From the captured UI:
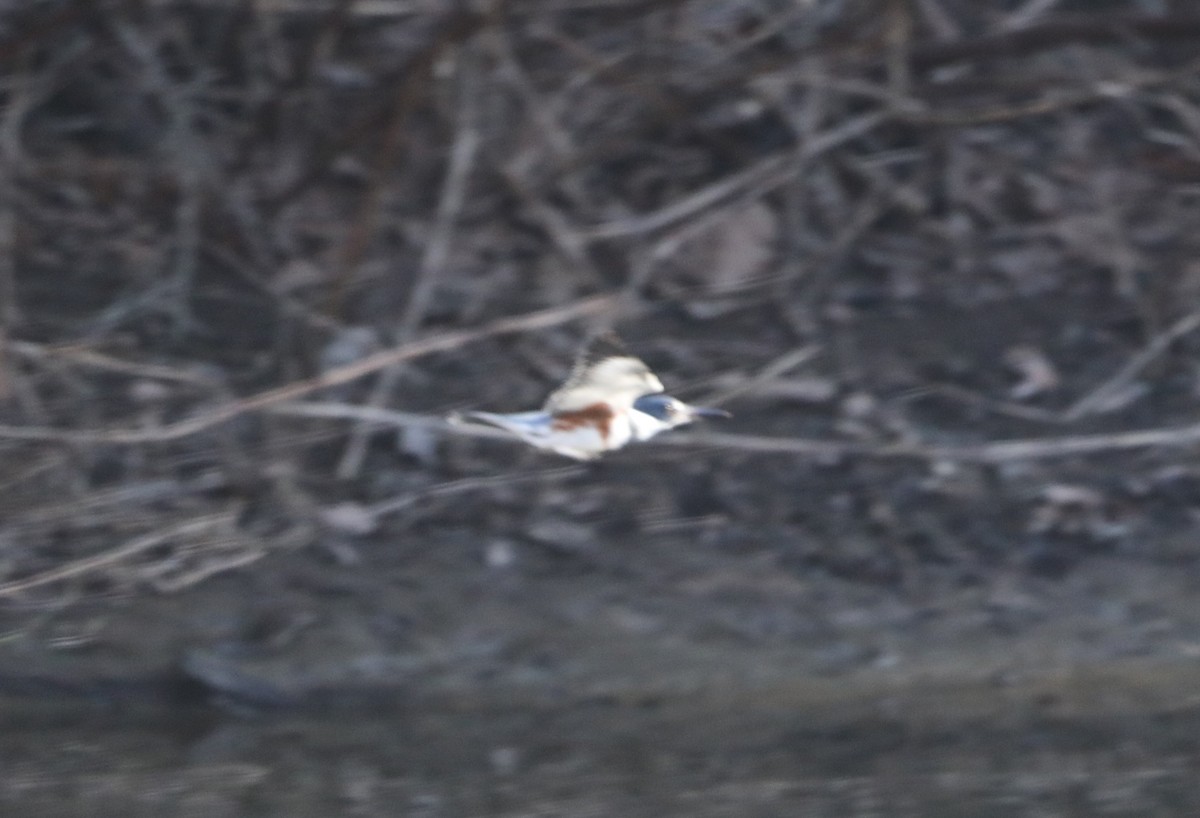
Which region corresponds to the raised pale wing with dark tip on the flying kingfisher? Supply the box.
[545,332,662,414]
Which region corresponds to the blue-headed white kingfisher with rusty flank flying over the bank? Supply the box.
[450,333,730,461]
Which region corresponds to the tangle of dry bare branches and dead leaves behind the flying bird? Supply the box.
[0,0,1200,686]
